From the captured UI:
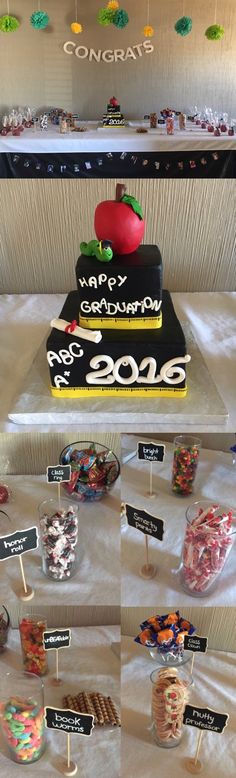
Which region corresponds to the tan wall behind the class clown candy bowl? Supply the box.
[121,603,236,652]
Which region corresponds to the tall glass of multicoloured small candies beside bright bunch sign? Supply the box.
[172,435,201,495]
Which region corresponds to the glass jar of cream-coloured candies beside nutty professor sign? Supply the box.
[150,668,190,748]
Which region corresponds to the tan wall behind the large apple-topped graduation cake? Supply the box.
[0,177,236,293]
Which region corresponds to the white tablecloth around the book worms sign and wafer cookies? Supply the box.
[0,625,120,778]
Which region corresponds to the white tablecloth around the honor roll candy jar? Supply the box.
[0,472,120,612]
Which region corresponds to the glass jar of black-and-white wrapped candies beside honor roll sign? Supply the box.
[38,499,79,581]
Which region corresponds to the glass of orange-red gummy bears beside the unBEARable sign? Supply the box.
[19,613,48,675]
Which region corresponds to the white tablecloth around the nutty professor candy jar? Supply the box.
[122,637,236,778]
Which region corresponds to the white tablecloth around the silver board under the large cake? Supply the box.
[0,292,236,432]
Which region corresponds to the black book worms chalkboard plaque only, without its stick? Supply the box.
[45,707,94,737]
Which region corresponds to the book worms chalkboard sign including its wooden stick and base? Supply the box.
[44,707,94,776]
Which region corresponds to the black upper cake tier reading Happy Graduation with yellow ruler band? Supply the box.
[76,246,162,329]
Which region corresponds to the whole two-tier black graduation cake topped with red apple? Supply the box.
[47,184,190,398]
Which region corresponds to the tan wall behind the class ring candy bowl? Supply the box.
[0,427,120,475]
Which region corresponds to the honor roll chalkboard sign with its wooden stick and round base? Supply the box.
[0,514,39,602]
